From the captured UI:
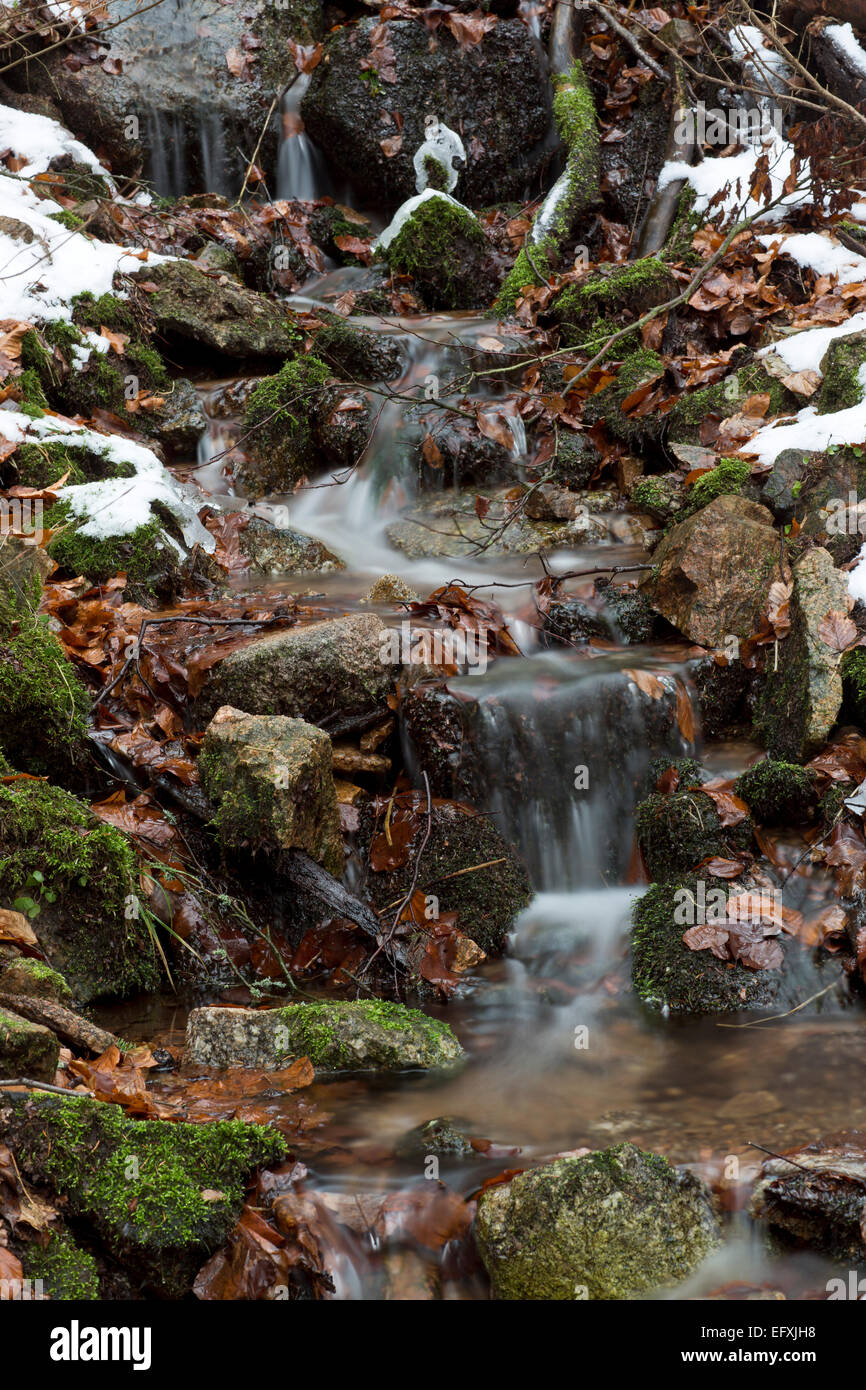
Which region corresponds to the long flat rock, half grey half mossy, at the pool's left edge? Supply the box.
[185,999,463,1072]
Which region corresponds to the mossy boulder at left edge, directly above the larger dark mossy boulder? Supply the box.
[0,585,89,774]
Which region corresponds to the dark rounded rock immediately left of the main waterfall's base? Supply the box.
[360,802,530,955]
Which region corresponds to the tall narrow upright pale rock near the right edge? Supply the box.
[755,546,848,762]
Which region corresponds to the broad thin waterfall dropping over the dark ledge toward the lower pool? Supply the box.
[428,652,691,892]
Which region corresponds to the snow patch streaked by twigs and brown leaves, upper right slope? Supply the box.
[659,129,812,222]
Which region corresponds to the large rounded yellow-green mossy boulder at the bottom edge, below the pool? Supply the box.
[475,1144,721,1301]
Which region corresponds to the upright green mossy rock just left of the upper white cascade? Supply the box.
[239,357,332,496]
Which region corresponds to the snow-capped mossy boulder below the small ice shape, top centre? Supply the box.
[377,190,493,309]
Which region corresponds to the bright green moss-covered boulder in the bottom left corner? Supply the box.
[0,1094,286,1298]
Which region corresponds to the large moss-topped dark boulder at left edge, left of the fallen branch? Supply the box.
[0,778,158,1001]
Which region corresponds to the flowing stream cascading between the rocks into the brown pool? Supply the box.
[96,125,866,1298]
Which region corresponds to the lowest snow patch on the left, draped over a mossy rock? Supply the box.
[0,410,215,553]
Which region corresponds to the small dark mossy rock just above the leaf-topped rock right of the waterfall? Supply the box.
[635,791,752,881]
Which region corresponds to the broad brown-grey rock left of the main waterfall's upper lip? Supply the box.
[196,613,396,727]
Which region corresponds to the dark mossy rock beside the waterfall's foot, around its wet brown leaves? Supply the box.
[631,876,780,1015]
